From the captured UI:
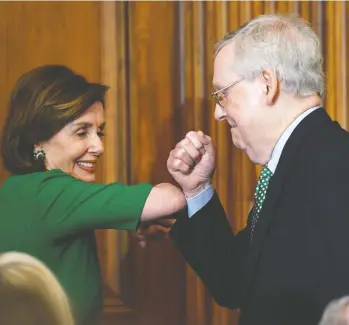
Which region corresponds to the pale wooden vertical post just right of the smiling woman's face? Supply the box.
[97,2,135,324]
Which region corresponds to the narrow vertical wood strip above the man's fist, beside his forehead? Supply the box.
[178,1,208,325]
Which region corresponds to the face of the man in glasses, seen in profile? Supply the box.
[213,44,269,163]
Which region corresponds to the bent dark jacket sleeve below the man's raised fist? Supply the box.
[171,193,249,308]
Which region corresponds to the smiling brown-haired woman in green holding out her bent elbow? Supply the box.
[0,65,186,325]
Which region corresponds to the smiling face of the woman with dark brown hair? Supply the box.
[36,102,105,182]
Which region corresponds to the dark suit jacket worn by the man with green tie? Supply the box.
[171,108,349,325]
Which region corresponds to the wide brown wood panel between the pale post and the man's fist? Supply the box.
[128,2,185,325]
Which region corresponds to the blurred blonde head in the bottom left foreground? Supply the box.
[0,252,74,325]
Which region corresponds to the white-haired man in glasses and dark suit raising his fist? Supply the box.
[167,15,349,325]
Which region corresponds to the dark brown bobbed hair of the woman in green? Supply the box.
[1,65,108,174]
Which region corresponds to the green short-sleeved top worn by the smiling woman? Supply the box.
[0,169,152,325]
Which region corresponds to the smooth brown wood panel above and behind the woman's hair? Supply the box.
[0,2,100,182]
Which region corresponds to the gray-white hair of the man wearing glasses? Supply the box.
[215,15,324,96]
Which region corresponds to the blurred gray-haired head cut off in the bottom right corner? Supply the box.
[319,296,349,325]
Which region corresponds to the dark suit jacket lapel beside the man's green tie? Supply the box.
[239,108,331,300]
